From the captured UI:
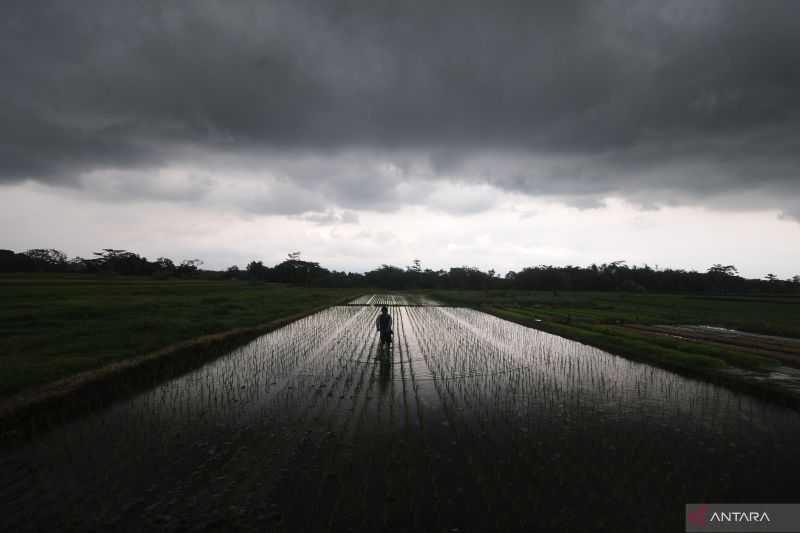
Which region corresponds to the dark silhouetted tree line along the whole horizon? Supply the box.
[0,248,800,293]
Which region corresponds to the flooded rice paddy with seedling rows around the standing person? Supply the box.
[0,296,800,532]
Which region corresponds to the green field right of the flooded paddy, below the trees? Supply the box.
[432,291,800,369]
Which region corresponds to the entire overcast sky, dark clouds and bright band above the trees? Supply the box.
[0,0,800,277]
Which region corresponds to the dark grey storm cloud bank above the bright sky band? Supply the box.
[0,0,800,216]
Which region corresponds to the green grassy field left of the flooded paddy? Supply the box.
[0,274,361,395]
